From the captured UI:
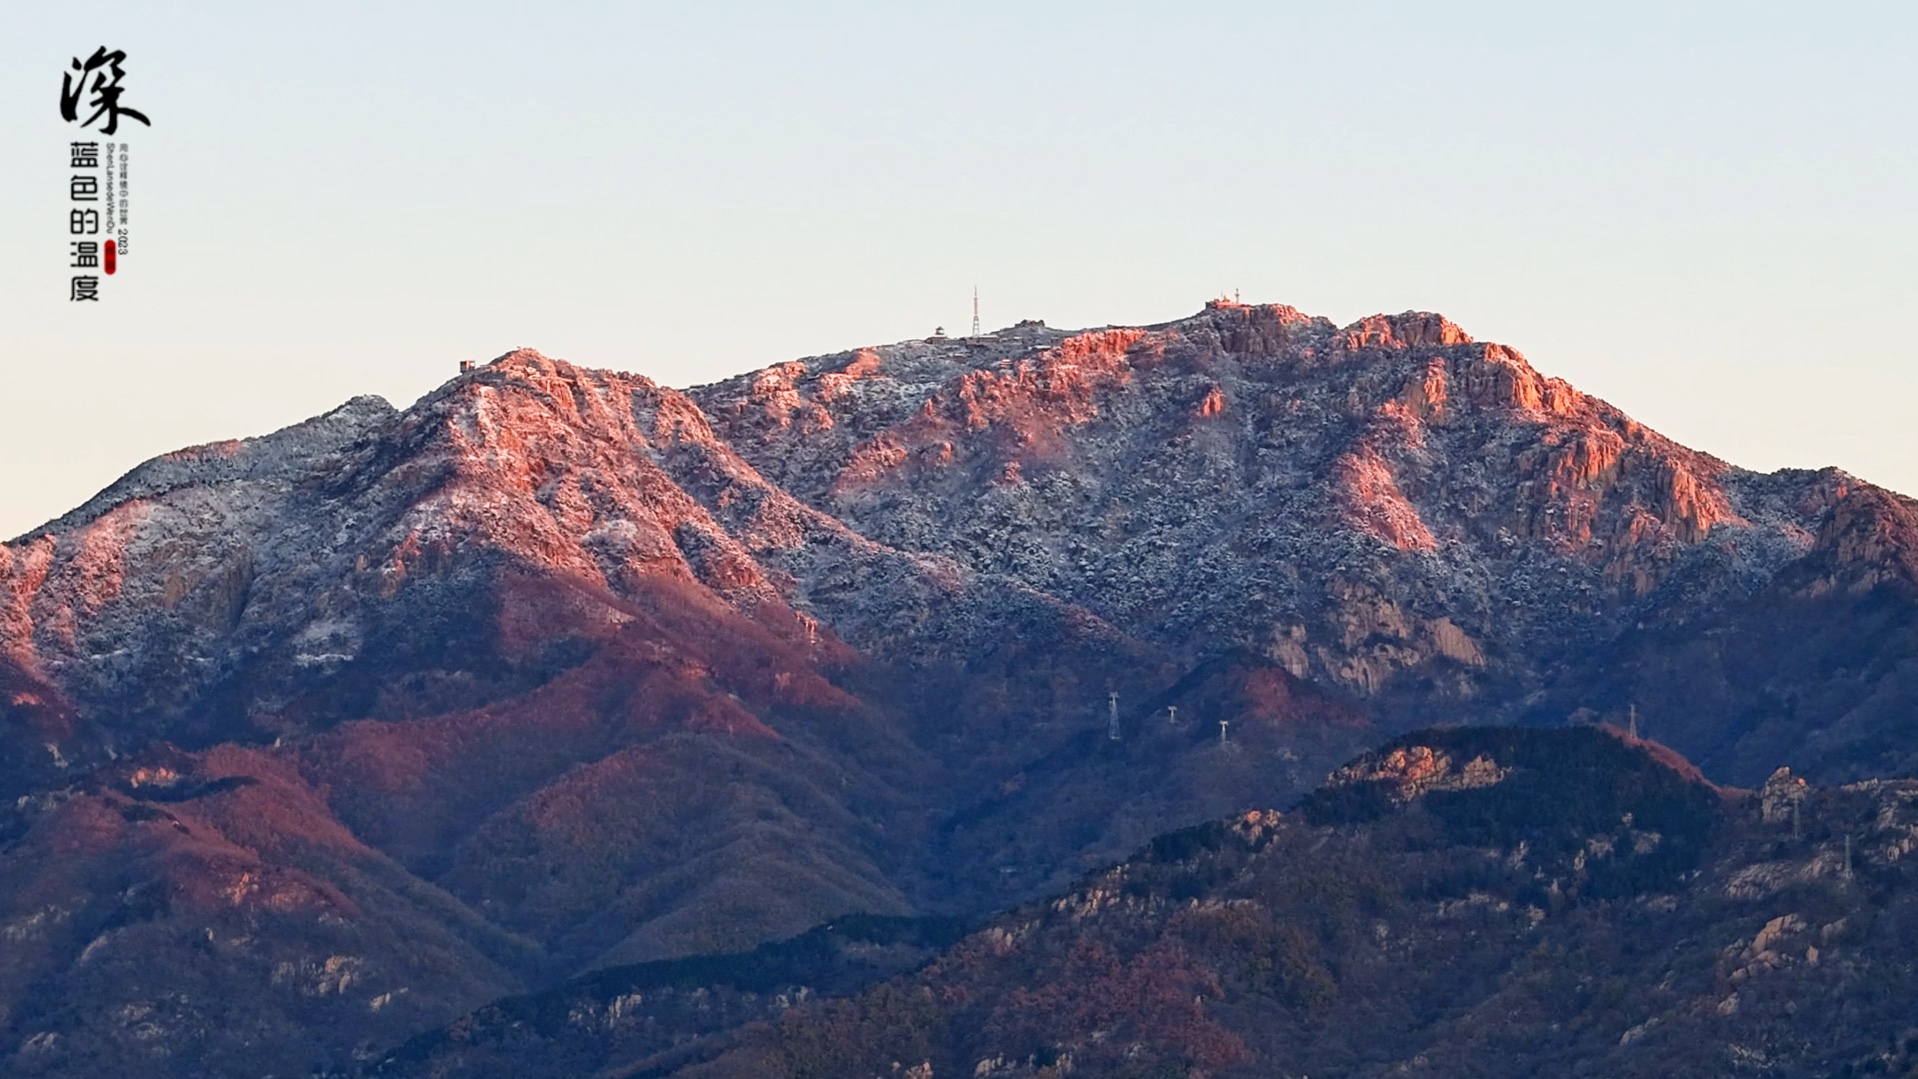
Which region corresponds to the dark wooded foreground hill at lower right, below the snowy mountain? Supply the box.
[389,726,1918,1079]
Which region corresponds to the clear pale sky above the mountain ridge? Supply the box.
[0,2,1918,537]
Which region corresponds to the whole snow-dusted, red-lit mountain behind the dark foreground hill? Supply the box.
[0,301,1918,1075]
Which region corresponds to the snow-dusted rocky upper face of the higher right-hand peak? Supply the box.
[694,305,1779,709]
